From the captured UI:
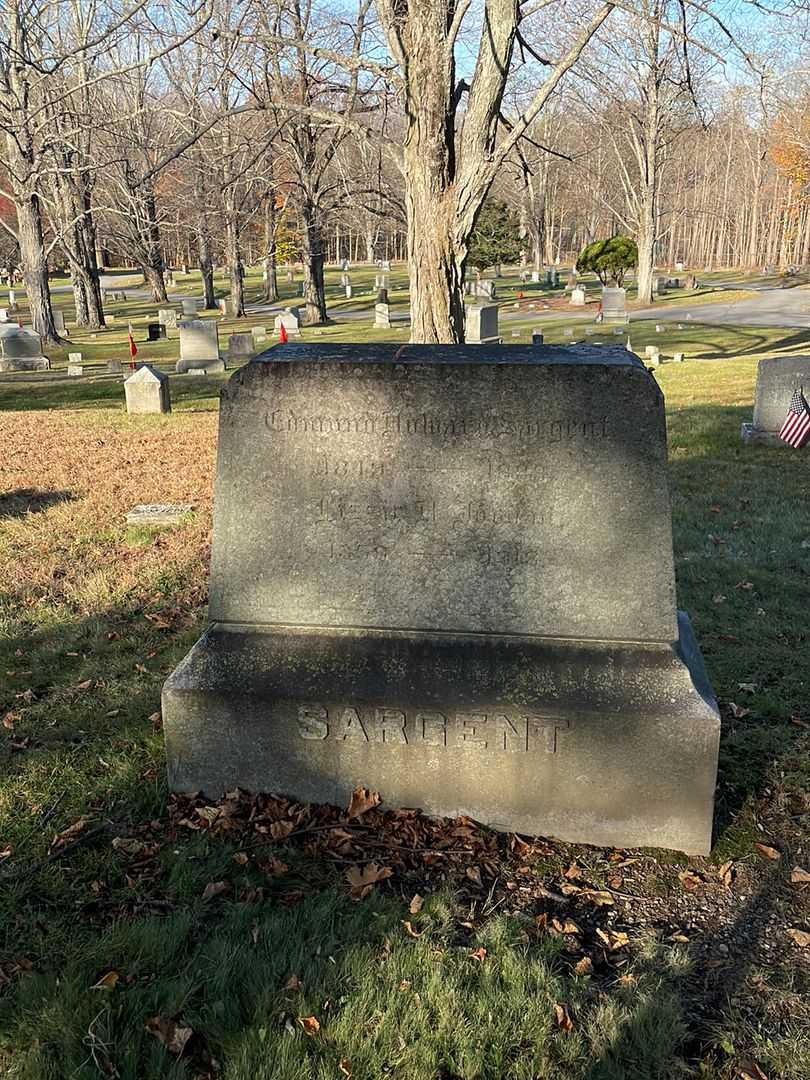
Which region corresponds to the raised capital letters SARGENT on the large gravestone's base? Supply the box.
[298,705,570,754]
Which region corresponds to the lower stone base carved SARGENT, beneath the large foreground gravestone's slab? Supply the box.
[163,613,719,854]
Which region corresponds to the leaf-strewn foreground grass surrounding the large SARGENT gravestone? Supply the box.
[0,359,810,1080]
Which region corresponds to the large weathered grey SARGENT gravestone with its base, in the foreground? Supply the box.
[162,343,720,854]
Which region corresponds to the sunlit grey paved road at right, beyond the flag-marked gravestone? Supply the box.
[631,285,810,327]
